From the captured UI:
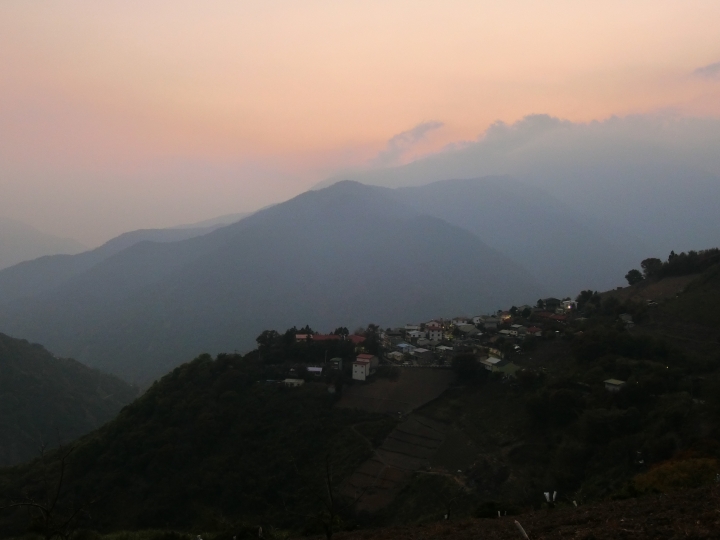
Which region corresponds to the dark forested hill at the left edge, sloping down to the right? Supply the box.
[0,334,137,466]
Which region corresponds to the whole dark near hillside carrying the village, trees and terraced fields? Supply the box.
[0,252,720,539]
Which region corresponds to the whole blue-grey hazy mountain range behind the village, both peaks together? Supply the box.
[0,169,712,383]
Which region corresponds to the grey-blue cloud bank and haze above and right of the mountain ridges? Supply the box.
[325,113,720,256]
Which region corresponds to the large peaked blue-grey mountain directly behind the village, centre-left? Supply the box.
[0,182,544,382]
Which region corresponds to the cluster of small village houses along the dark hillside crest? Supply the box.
[273,291,636,392]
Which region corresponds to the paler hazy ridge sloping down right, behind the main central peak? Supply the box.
[397,176,637,297]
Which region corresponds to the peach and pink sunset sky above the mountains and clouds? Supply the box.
[0,0,720,245]
